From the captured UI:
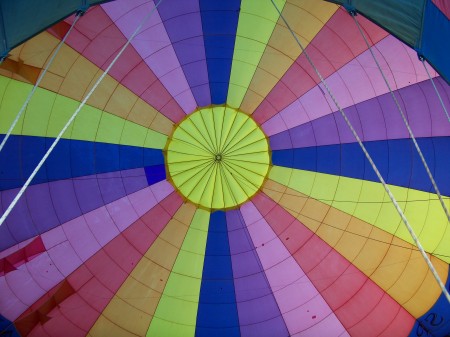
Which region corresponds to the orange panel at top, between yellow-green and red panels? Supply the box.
[241,0,339,114]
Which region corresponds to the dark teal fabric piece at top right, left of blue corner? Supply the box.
[327,0,426,48]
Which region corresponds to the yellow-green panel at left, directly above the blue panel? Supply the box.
[0,76,167,149]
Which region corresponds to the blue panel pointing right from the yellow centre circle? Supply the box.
[272,137,450,196]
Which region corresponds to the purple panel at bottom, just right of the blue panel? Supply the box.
[226,210,289,337]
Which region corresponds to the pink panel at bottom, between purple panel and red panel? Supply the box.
[241,202,345,336]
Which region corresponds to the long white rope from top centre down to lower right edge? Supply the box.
[270,0,450,303]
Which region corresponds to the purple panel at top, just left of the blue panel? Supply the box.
[158,0,211,106]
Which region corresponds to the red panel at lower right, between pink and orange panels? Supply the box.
[252,194,415,336]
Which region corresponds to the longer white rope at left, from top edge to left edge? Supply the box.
[0,0,163,226]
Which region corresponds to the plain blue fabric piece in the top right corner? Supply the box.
[419,0,450,83]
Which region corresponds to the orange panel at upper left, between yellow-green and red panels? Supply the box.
[0,32,173,134]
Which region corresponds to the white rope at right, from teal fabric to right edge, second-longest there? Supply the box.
[350,13,450,221]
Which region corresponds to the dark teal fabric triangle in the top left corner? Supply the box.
[0,0,106,55]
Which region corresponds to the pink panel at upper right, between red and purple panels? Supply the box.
[262,36,436,136]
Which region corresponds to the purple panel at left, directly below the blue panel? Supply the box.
[0,168,148,250]
